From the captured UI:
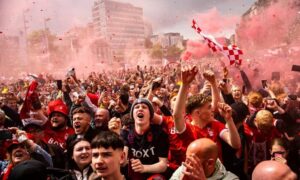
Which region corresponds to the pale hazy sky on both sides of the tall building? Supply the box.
[0,0,255,38]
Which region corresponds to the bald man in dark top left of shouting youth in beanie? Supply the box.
[94,108,110,130]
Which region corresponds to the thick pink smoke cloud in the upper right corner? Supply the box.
[237,0,299,49]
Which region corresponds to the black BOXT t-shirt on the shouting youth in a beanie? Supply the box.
[121,125,169,179]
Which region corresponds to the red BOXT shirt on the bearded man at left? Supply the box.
[44,124,75,149]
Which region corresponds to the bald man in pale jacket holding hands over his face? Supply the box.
[171,138,239,180]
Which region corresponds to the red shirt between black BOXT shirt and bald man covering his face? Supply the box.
[161,116,194,170]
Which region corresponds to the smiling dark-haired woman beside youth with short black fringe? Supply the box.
[62,138,93,180]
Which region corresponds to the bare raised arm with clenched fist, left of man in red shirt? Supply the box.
[173,66,198,132]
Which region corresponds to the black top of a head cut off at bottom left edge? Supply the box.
[8,160,47,180]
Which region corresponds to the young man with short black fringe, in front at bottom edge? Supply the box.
[91,131,125,180]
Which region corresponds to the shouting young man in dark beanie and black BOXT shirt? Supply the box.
[121,98,169,180]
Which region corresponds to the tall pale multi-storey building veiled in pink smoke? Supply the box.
[92,0,145,63]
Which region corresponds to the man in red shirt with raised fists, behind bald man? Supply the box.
[174,66,241,159]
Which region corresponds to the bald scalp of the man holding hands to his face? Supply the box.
[186,138,218,160]
